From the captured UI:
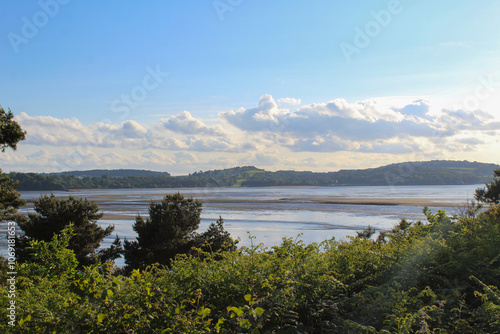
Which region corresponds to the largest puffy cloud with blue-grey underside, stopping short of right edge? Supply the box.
[220,95,437,140]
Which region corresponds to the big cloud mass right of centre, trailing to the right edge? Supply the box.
[220,95,500,154]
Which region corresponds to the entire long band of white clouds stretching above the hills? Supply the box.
[8,95,500,170]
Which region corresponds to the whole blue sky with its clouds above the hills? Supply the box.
[0,0,500,175]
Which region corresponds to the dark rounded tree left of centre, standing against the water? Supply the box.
[124,193,235,270]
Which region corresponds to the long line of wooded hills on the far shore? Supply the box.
[10,160,500,190]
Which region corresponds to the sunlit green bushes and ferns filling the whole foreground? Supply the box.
[0,198,500,333]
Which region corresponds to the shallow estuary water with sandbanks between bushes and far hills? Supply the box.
[14,185,482,253]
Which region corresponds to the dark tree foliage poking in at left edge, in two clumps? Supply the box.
[0,106,26,221]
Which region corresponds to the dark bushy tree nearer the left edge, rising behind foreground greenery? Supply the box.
[18,194,121,266]
